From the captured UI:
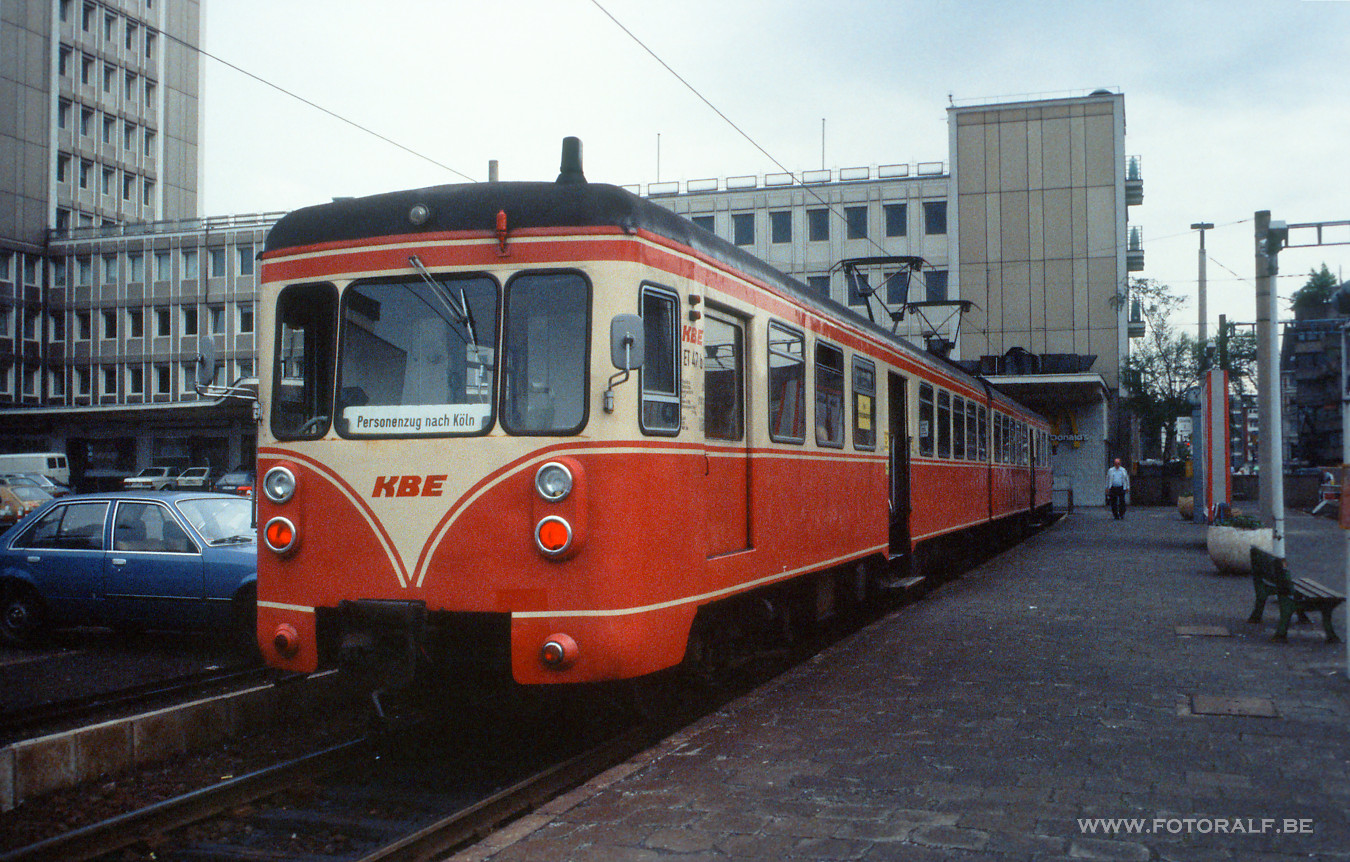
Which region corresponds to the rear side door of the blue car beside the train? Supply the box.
[9,500,109,623]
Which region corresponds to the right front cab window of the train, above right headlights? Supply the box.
[502,272,590,434]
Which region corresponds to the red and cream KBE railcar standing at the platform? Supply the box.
[258,145,1049,684]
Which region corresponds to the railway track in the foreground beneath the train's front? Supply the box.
[0,726,659,862]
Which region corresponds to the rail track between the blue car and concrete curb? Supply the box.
[0,662,275,742]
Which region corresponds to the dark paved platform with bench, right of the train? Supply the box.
[456,509,1350,862]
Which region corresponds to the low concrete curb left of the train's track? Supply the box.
[0,672,338,811]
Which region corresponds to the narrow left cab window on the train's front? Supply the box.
[271,285,338,440]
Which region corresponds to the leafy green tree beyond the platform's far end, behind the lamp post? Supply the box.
[1116,278,1199,461]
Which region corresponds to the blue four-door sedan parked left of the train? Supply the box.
[0,491,258,646]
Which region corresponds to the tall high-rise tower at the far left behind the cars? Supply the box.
[0,0,201,415]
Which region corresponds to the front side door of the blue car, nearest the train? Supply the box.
[105,500,205,629]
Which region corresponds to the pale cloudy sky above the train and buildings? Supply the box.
[201,0,1350,335]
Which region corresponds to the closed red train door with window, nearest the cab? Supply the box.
[703,310,751,557]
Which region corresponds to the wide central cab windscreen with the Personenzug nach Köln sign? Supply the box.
[338,274,498,437]
